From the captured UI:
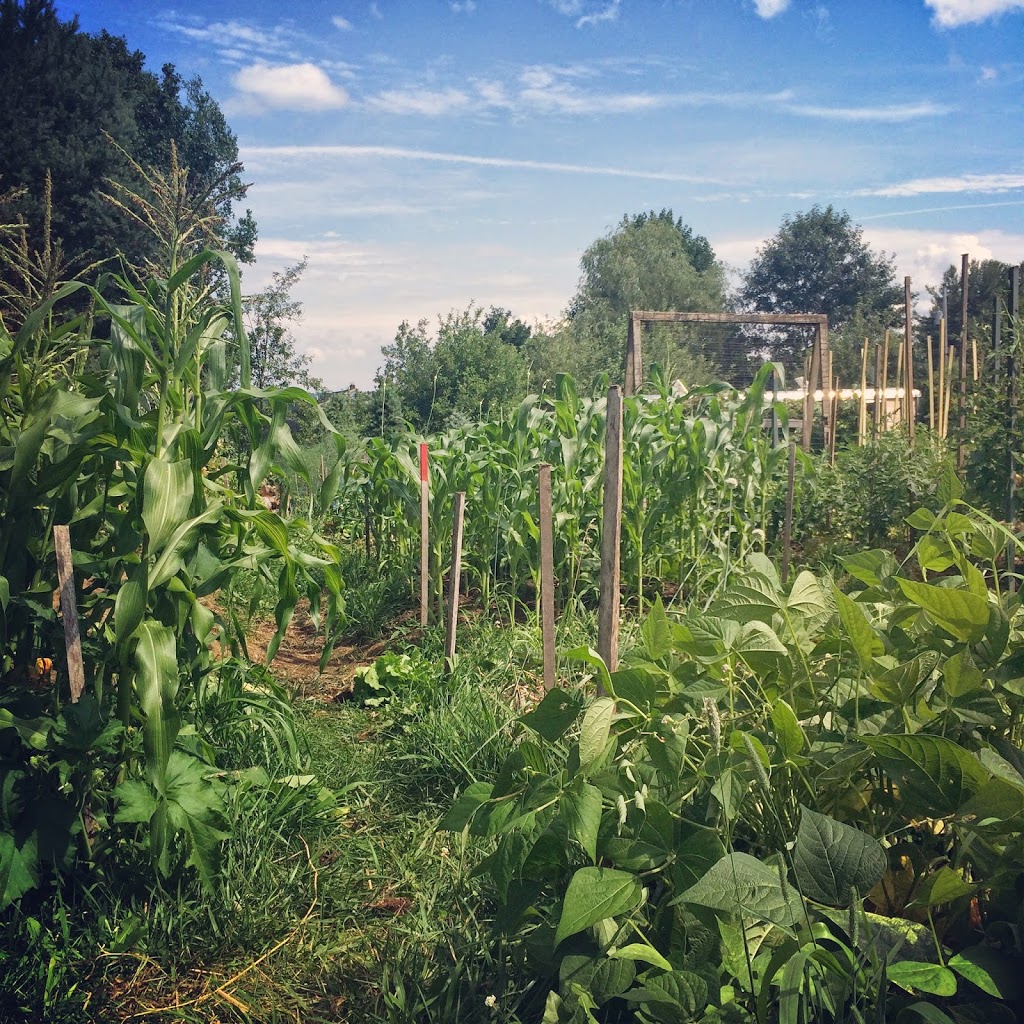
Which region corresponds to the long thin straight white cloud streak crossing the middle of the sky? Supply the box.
[242,145,728,185]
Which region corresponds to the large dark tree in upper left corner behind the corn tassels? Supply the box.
[0,0,255,288]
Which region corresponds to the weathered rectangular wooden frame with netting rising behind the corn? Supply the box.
[623,309,833,452]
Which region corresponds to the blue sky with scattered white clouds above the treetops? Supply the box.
[56,0,1024,387]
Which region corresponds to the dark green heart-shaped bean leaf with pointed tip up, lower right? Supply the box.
[793,806,886,906]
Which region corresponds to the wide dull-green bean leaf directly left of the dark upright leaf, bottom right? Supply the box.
[673,853,804,933]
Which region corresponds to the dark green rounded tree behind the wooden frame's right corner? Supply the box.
[740,206,903,373]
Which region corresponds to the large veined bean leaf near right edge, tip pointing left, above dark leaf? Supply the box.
[860,733,989,817]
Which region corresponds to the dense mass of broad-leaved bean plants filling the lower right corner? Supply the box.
[440,503,1024,1024]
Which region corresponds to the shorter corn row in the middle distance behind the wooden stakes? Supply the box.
[337,367,785,610]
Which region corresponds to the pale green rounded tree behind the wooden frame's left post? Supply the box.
[552,210,725,382]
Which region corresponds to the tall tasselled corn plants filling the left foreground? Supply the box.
[0,149,343,923]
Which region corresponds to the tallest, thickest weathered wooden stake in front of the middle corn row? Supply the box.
[597,386,623,679]
